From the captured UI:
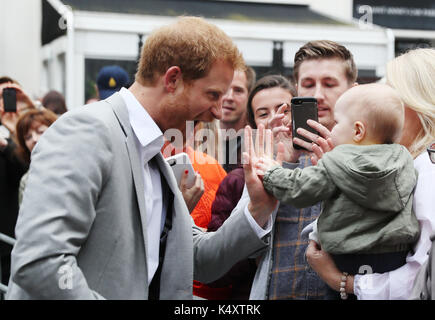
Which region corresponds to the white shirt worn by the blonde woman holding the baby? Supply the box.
[354,151,435,300]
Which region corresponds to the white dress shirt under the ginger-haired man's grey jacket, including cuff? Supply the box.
[119,88,272,284]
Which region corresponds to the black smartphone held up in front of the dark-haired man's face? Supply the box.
[291,97,319,150]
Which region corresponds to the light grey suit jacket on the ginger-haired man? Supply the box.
[7,94,269,299]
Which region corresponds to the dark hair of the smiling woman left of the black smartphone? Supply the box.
[247,74,296,129]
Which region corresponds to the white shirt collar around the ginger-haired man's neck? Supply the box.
[119,88,164,161]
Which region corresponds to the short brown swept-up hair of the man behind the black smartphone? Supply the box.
[293,40,358,84]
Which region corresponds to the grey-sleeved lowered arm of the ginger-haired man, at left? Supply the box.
[11,112,113,299]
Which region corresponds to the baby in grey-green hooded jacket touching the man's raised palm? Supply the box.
[256,84,419,296]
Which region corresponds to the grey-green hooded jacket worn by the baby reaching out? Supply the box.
[263,144,420,254]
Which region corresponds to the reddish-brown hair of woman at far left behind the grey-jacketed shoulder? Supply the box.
[15,108,57,163]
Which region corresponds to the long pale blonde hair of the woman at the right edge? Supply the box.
[387,48,435,158]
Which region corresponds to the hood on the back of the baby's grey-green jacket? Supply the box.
[321,144,417,211]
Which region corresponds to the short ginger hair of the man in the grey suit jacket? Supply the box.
[136,17,244,85]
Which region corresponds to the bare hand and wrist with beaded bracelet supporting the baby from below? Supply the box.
[305,240,354,294]
